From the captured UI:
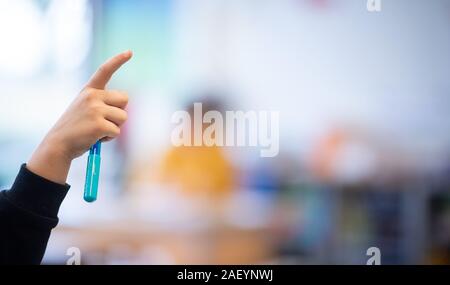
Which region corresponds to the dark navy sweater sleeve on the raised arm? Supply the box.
[0,164,70,264]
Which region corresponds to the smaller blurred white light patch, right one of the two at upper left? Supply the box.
[48,0,93,70]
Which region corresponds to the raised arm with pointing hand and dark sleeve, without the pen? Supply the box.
[0,51,132,263]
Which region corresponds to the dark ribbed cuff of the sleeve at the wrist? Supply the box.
[6,164,70,218]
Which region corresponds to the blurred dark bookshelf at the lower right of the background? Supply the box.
[278,175,450,264]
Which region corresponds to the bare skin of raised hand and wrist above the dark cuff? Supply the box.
[26,51,132,184]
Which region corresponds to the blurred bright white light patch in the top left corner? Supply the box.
[0,0,45,76]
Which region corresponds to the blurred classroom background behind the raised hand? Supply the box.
[0,0,450,264]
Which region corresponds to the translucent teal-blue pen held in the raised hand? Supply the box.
[83,141,102,203]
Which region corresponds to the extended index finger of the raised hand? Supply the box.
[86,51,133,89]
